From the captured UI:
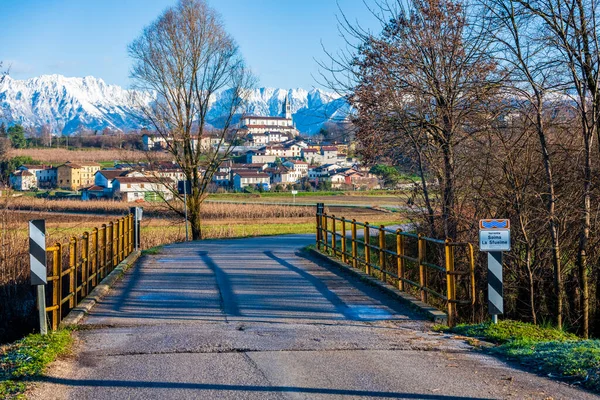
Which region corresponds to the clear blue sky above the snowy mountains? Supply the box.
[0,0,375,89]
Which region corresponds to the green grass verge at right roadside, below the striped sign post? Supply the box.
[434,320,600,393]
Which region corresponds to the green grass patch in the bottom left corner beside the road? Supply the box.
[0,329,73,399]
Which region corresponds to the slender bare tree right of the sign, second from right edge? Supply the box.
[482,0,564,328]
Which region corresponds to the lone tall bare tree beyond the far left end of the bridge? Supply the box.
[129,0,253,240]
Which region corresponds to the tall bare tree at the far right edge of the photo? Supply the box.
[519,0,600,337]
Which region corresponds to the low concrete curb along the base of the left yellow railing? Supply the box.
[60,251,142,327]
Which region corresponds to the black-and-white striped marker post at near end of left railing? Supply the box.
[29,219,48,335]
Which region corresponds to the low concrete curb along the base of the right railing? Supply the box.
[305,248,448,325]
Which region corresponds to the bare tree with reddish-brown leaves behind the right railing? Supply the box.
[333,0,497,238]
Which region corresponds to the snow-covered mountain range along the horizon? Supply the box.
[0,75,349,134]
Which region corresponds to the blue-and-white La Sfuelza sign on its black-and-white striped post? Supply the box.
[479,219,510,324]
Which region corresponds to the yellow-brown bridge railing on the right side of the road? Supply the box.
[316,207,475,326]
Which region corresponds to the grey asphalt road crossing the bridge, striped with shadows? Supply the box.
[29,235,597,400]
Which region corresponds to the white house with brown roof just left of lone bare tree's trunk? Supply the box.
[113,177,173,202]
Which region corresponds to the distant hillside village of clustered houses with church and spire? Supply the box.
[10,95,379,202]
